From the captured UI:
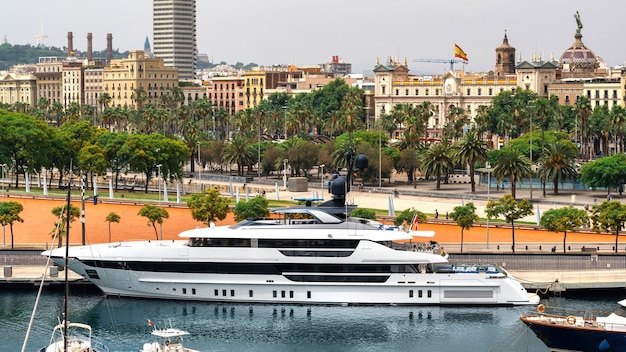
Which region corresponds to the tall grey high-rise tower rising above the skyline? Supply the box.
[152,0,197,80]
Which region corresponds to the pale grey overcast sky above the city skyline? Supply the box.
[0,0,626,73]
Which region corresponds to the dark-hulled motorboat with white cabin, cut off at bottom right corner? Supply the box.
[520,299,626,352]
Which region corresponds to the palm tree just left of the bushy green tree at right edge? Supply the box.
[540,140,578,194]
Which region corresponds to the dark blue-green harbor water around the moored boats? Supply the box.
[0,286,624,352]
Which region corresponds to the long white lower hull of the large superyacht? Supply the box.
[53,252,539,306]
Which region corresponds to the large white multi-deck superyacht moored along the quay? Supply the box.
[44,202,539,305]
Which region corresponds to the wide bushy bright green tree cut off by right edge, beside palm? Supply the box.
[580,154,626,194]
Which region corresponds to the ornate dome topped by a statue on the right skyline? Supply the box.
[559,11,600,76]
